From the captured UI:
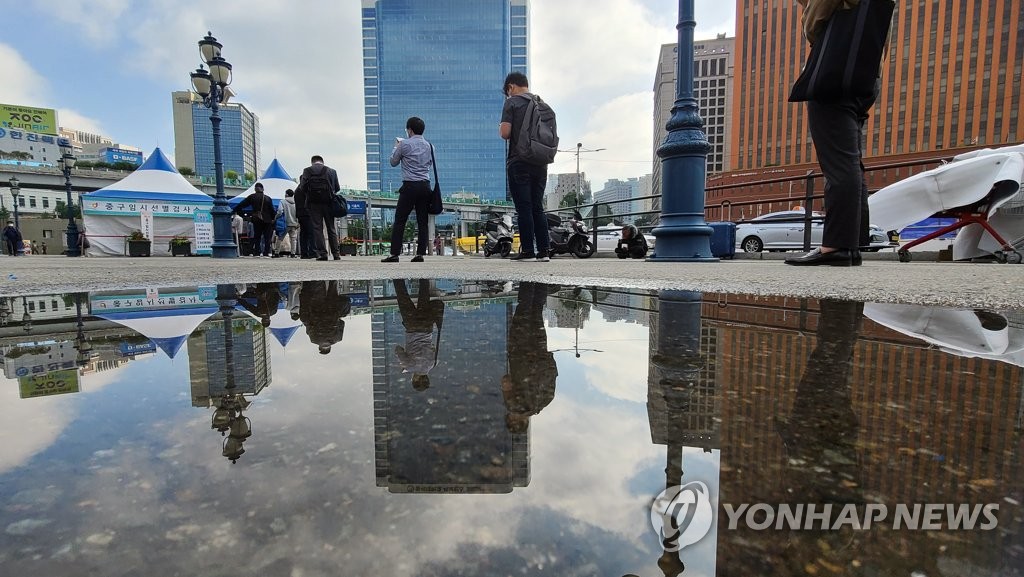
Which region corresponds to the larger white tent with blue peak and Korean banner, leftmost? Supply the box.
[82,148,213,256]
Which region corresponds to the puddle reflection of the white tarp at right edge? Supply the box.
[864,302,1024,367]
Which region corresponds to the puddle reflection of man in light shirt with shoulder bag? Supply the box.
[394,279,444,390]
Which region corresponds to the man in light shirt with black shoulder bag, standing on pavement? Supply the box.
[381,116,434,262]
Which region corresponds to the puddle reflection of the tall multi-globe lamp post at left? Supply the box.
[210,285,252,464]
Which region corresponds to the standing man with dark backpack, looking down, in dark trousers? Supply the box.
[498,72,558,262]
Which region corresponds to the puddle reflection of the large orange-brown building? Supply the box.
[700,295,1024,575]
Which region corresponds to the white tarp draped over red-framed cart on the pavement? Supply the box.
[867,145,1024,260]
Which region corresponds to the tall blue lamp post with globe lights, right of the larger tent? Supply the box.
[189,32,239,258]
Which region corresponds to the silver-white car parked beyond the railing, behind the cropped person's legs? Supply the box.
[736,210,895,252]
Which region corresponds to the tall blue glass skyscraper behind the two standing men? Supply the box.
[362,0,529,201]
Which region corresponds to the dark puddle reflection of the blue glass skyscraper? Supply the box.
[371,282,529,494]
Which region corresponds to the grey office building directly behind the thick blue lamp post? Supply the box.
[651,34,736,201]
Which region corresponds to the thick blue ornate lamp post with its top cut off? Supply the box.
[648,0,718,262]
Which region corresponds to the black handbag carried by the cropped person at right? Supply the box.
[790,0,896,102]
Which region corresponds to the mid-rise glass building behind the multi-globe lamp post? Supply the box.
[171,91,263,178]
